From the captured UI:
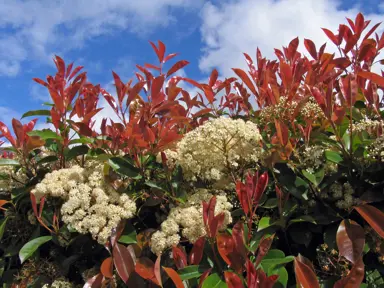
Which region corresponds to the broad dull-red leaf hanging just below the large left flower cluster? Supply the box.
[113,243,135,283]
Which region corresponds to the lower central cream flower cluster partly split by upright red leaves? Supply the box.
[151,189,232,255]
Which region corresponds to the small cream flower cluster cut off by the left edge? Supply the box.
[0,166,28,191]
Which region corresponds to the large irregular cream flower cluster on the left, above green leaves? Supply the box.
[32,161,136,244]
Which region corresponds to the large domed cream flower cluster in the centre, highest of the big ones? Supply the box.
[176,117,261,181]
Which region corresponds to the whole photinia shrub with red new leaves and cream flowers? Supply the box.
[0,13,384,288]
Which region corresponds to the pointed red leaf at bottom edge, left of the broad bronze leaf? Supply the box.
[294,254,320,288]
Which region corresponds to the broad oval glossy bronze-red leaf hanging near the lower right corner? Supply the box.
[336,220,365,264]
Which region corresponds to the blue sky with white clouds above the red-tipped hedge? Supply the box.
[0,0,384,129]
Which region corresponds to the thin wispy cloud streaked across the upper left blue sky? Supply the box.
[0,0,203,76]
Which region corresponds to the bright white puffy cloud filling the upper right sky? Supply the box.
[199,0,384,76]
